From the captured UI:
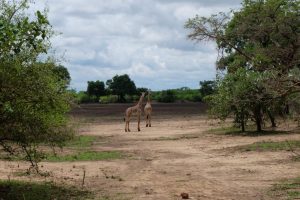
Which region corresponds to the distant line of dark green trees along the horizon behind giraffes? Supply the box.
[72,74,215,103]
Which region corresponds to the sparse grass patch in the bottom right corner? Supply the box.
[269,177,300,200]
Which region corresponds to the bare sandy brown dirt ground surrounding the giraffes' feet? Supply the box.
[0,103,300,200]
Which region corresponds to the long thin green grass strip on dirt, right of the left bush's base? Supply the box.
[44,151,124,162]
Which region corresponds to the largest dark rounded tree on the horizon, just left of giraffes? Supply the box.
[106,74,136,102]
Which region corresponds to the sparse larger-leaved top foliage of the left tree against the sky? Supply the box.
[0,0,52,63]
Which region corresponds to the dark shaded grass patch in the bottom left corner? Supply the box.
[0,180,93,200]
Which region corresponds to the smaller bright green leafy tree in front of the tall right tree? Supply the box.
[205,68,272,131]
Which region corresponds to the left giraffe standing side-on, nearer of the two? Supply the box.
[124,92,145,132]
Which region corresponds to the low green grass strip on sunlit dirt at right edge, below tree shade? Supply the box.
[239,140,300,151]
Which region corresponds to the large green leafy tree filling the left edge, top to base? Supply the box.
[0,0,72,170]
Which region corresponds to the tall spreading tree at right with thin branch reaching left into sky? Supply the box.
[185,0,300,131]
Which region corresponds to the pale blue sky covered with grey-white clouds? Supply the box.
[34,0,242,90]
